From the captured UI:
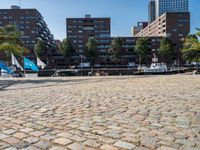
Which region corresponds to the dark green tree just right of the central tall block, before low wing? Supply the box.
[108,38,123,65]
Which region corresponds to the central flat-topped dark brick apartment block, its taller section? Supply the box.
[66,15,111,64]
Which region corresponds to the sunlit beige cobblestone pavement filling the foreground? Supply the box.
[0,75,200,150]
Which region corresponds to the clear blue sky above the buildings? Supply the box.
[0,0,200,39]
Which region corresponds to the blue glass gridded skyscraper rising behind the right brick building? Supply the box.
[155,0,189,18]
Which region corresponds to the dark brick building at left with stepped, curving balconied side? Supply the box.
[0,6,55,61]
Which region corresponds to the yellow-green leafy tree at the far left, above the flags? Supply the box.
[0,25,28,61]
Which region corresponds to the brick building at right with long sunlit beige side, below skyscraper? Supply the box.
[135,12,190,62]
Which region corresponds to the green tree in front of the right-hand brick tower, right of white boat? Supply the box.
[159,37,173,62]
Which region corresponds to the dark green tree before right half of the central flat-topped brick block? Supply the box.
[86,38,98,75]
